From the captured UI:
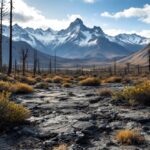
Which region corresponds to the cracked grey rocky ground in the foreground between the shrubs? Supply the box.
[0,86,150,150]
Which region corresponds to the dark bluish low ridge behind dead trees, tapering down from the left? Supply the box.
[3,36,106,68]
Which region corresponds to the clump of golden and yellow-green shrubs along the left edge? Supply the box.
[0,74,33,129]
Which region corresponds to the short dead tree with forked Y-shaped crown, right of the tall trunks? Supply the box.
[21,48,29,76]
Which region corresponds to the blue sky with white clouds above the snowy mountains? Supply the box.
[10,0,150,37]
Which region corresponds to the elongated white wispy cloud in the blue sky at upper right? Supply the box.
[101,4,150,24]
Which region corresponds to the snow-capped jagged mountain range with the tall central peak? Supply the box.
[3,19,150,61]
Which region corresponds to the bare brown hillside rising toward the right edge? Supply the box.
[118,44,150,65]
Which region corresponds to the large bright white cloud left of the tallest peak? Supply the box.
[5,0,82,30]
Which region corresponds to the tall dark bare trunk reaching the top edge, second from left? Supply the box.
[8,0,13,75]
